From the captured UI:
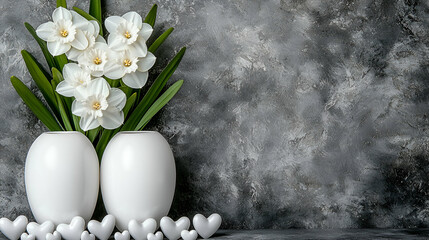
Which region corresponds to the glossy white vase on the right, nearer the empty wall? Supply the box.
[100,131,176,231]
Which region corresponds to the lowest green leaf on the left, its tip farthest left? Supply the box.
[10,76,62,131]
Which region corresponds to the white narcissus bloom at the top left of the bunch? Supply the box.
[36,7,91,56]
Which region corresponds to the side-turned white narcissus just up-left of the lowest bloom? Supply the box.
[56,63,91,97]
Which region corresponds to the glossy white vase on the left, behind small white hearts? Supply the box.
[25,132,100,225]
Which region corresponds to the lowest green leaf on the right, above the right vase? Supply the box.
[134,80,183,131]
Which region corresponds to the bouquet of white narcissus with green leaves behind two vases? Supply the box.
[11,0,186,158]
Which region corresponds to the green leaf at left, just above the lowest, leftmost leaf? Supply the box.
[21,50,60,118]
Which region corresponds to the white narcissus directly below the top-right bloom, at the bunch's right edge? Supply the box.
[104,51,156,88]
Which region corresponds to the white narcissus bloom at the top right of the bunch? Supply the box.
[104,12,153,57]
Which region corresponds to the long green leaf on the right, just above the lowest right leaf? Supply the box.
[121,47,186,131]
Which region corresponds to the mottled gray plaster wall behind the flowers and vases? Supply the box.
[0,0,429,229]
